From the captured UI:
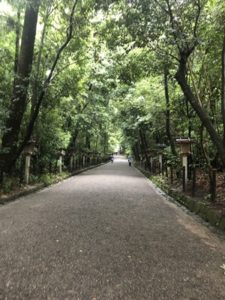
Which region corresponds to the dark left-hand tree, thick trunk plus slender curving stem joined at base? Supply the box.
[0,0,81,178]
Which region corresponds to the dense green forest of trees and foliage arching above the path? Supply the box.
[0,0,225,181]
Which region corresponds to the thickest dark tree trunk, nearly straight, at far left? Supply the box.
[0,0,40,172]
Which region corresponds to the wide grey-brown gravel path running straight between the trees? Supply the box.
[0,159,225,300]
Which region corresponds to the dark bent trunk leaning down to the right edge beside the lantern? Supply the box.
[175,54,225,168]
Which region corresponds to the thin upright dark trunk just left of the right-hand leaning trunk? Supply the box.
[164,67,177,156]
